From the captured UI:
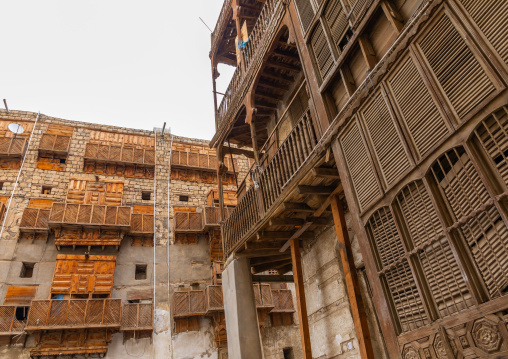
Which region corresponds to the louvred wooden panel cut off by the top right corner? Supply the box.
[459,0,508,63]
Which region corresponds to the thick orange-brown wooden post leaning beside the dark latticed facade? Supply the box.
[331,196,374,359]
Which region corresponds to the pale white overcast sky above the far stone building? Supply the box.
[0,0,234,139]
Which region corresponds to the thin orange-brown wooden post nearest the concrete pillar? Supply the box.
[291,239,312,359]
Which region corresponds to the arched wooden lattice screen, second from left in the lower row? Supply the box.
[396,181,474,317]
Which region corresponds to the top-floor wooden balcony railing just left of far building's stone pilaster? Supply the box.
[84,143,155,166]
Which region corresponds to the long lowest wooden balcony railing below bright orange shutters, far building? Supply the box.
[25,299,122,331]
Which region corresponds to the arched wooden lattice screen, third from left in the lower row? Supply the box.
[431,147,508,298]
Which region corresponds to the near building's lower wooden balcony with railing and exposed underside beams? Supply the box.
[222,110,338,262]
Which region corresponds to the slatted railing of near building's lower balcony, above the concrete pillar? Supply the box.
[223,110,318,253]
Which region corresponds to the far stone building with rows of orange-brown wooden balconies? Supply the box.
[0,110,301,359]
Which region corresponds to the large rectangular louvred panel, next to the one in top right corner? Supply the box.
[419,10,497,119]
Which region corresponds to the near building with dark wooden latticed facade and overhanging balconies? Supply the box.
[210,0,508,359]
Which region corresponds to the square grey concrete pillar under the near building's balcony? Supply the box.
[222,258,264,359]
